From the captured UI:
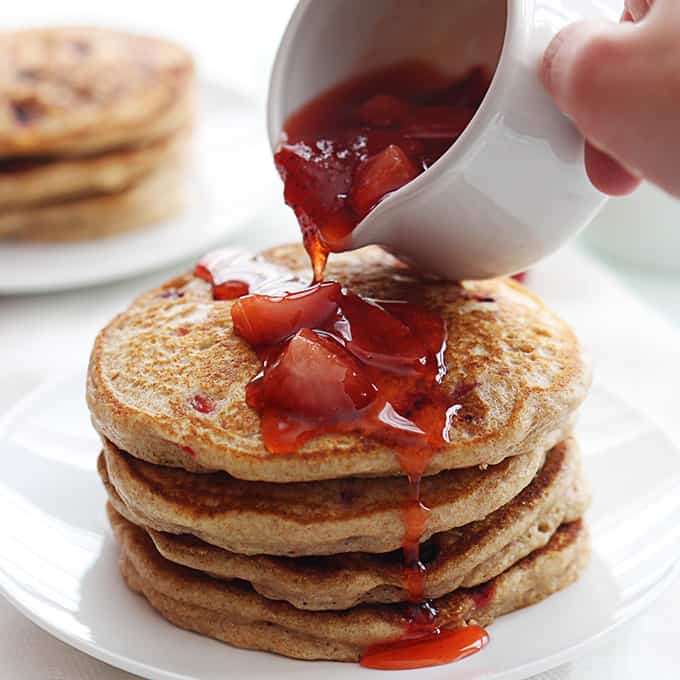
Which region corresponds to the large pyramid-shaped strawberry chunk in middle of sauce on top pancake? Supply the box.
[259,329,375,423]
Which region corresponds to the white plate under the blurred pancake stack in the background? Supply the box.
[0,83,278,294]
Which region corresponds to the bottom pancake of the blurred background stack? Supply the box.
[0,159,184,242]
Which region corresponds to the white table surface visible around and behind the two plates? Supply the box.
[0,0,680,680]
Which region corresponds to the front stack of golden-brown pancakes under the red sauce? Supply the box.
[87,246,589,661]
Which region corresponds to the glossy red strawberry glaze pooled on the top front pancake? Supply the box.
[232,283,452,454]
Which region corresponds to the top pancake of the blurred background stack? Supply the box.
[0,27,193,158]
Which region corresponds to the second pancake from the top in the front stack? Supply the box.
[99,441,545,556]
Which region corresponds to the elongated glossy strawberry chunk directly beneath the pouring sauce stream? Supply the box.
[231,282,341,346]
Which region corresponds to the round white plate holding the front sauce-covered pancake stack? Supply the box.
[0,374,680,680]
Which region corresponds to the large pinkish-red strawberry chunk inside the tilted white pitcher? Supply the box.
[349,144,418,217]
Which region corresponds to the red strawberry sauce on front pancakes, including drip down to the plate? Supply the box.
[194,244,488,668]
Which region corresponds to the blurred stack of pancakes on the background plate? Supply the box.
[0,28,194,241]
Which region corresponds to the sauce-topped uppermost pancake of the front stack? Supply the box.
[87,246,590,482]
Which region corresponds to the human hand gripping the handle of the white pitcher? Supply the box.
[542,0,680,197]
